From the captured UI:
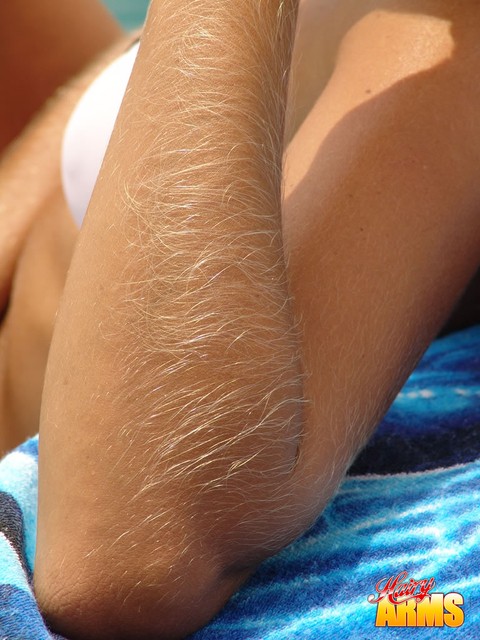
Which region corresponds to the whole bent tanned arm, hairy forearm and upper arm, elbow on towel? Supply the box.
[0,0,480,639]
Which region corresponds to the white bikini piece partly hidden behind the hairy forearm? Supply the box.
[61,43,139,226]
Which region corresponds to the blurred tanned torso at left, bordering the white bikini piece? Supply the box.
[0,35,135,452]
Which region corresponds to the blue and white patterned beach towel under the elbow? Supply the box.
[0,326,480,640]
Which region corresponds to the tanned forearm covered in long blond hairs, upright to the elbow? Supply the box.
[36,0,302,638]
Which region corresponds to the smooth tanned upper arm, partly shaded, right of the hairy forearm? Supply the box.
[284,2,480,502]
